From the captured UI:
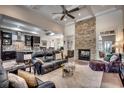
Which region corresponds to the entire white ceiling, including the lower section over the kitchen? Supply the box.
[0,5,123,34]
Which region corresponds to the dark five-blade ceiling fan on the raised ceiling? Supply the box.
[52,5,79,20]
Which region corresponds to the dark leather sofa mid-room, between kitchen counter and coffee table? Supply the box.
[32,51,68,74]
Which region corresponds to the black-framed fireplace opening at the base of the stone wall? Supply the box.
[78,49,90,61]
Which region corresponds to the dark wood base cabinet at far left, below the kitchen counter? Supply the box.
[1,51,16,61]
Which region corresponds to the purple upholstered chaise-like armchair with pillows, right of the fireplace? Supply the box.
[89,54,121,72]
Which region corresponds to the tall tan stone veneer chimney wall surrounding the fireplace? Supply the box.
[75,18,96,59]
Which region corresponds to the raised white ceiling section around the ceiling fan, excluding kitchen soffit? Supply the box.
[24,5,123,25]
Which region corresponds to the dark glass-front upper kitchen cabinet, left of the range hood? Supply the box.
[2,32,12,45]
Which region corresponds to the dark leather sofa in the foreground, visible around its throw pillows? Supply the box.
[0,64,55,88]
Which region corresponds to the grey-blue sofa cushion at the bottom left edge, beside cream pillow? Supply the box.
[0,64,9,88]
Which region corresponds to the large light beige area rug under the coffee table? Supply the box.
[37,64,103,88]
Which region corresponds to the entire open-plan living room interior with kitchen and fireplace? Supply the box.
[0,5,124,88]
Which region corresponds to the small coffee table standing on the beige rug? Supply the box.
[62,62,75,77]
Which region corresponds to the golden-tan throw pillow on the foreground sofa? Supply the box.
[18,70,38,88]
